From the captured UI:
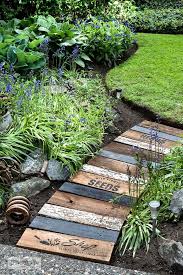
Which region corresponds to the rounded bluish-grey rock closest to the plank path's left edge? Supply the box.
[46,159,70,181]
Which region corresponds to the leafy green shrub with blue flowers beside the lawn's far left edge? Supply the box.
[79,18,134,66]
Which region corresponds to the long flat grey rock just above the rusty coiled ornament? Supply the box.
[11,177,50,198]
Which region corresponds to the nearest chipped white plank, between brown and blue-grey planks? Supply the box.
[39,203,124,231]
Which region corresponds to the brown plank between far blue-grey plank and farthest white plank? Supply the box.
[121,130,177,149]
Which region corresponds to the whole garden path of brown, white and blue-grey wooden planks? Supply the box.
[17,121,183,262]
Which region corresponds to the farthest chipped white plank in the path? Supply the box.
[115,136,170,154]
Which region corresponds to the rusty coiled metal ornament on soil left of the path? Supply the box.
[6,196,30,225]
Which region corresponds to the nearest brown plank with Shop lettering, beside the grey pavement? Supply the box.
[17,228,114,262]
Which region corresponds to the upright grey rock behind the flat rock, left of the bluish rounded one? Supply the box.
[21,148,46,175]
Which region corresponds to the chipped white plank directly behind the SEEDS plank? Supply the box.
[81,164,129,181]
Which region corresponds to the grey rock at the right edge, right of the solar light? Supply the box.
[169,189,183,216]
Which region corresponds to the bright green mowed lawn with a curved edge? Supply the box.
[106,33,183,124]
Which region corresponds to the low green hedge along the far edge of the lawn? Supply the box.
[131,8,183,33]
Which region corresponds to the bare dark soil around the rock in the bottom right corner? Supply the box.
[111,221,183,275]
